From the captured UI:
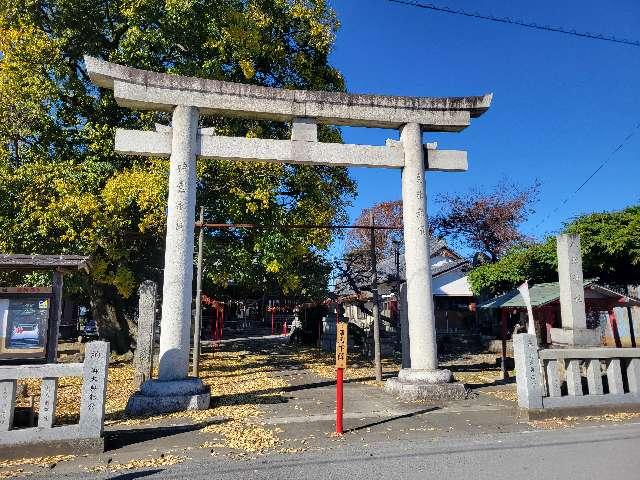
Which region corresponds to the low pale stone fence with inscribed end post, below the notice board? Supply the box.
[0,342,109,447]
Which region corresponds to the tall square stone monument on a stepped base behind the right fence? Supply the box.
[551,235,600,346]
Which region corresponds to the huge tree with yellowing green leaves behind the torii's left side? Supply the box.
[0,0,355,351]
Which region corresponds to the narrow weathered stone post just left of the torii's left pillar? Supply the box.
[134,280,158,388]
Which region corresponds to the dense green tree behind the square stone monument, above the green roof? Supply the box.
[469,206,640,294]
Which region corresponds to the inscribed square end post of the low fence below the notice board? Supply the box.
[80,342,109,438]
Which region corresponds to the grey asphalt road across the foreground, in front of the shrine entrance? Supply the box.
[48,424,640,480]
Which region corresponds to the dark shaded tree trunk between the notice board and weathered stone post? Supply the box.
[89,284,131,355]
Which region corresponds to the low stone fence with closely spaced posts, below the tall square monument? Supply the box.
[513,333,640,410]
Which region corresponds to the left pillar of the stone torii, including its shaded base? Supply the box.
[127,105,211,416]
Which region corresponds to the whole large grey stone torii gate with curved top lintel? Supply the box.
[85,57,492,410]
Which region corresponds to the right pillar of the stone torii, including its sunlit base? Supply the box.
[385,123,467,400]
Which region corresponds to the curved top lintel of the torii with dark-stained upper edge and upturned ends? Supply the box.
[84,56,492,132]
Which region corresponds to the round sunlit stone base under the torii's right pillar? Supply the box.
[384,368,469,402]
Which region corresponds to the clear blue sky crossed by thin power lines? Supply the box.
[330,0,640,253]
